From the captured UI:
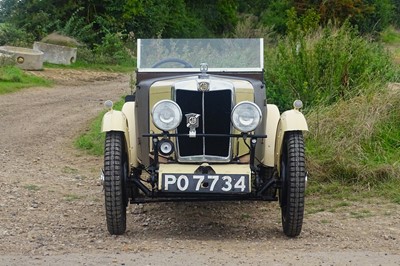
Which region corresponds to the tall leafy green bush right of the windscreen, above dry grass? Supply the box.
[265,23,398,108]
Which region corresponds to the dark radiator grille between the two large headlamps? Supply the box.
[176,90,232,160]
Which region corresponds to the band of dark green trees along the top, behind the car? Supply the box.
[0,0,400,42]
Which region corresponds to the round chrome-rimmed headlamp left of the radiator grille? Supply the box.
[151,100,182,131]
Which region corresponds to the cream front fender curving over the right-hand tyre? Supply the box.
[275,110,308,174]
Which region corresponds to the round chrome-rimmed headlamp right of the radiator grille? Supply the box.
[231,101,262,133]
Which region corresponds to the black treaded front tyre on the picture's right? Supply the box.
[279,131,307,237]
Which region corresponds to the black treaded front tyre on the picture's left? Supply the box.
[104,131,128,235]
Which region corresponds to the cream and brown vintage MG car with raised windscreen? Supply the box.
[101,39,308,237]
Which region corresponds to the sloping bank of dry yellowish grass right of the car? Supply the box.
[307,87,400,185]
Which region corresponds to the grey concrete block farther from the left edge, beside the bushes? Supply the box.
[33,42,77,65]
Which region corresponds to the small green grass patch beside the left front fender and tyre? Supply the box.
[74,99,124,156]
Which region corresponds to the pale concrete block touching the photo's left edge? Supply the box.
[0,46,43,70]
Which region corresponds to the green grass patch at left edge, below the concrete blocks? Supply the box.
[0,66,52,94]
